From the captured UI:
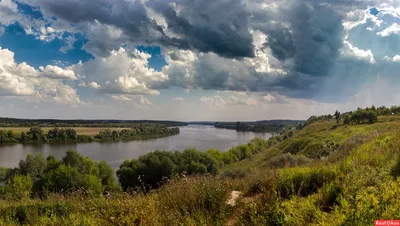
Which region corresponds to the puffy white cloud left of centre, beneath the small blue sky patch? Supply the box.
[71,48,168,95]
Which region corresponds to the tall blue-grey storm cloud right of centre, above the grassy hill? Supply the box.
[252,1,343,76]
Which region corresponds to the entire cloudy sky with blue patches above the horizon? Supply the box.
[0,0,400,121]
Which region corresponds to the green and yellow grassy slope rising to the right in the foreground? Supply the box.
[0,117,400,225]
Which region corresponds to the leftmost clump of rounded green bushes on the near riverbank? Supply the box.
[0,151,119,200]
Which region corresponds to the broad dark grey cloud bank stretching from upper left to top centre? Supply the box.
[23,0,253,58]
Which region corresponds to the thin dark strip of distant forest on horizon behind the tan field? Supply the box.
[0,118,187,128]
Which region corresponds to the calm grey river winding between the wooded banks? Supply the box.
[0,125,272,169]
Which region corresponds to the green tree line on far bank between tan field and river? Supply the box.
[0,123,179,143]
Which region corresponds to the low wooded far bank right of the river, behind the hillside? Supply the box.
[215,120,303,132]
